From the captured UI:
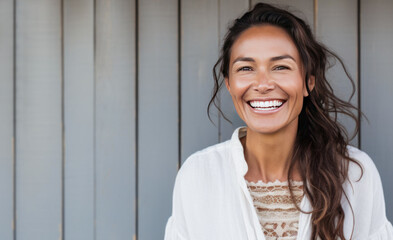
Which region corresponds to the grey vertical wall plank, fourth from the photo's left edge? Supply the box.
[95,0,136,240]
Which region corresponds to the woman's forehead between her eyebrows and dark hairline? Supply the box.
[230,25,300,62]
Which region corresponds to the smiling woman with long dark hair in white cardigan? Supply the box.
[165,3,393,240]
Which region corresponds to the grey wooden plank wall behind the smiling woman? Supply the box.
[0,0,393,240]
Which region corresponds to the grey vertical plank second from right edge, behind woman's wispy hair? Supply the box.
[316,0,358,146]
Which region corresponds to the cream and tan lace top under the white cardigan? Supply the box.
[246,180,303,240]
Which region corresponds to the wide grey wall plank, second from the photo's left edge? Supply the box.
[16,0,62,240]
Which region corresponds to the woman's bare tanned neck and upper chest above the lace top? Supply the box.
[241,120,301,182]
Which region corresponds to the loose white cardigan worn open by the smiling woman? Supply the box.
[165,128,393,240]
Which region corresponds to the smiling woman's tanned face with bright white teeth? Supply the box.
[225,25,314,134]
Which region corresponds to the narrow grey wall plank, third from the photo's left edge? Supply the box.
[64,0,95,240]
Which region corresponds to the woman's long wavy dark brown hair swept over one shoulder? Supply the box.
[208,3,363,240]
